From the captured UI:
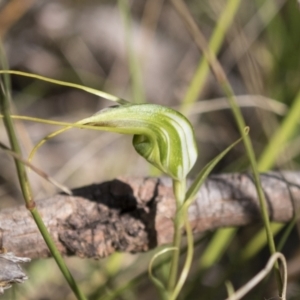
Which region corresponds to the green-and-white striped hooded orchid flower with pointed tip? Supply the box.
[78,104,197,180]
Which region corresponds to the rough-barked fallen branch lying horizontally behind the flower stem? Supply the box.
[0,172,300,258]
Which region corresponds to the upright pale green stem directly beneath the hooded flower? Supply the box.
[168,179,186,294]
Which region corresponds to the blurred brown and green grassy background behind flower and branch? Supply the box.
[0,0,300,300]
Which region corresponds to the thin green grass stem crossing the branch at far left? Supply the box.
[0,77,86,300]
